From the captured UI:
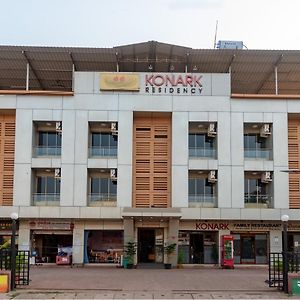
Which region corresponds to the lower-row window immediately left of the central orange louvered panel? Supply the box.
[89,177,117,206]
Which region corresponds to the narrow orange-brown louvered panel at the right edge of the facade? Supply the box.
[288,120,300,208]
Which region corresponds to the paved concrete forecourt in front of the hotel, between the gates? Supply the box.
[0,266,297,299]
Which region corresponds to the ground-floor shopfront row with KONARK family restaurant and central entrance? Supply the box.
[15,217,300,265]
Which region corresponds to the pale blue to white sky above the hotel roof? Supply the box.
[0,0,300,50]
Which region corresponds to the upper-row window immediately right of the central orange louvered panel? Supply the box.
[189,133,216,157]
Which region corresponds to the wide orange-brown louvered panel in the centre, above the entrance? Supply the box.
[133,116,171,208]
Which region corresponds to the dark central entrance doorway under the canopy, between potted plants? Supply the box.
[138,228,155,263]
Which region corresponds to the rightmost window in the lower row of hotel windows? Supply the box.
[244,178,271,207]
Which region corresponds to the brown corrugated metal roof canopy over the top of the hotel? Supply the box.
[0,41,300,95]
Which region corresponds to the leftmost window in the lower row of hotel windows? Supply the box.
[33,175,60,206]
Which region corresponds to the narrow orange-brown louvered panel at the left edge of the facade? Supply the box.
[0,115,15,206]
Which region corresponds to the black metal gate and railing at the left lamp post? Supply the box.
[0,249,30,285]
